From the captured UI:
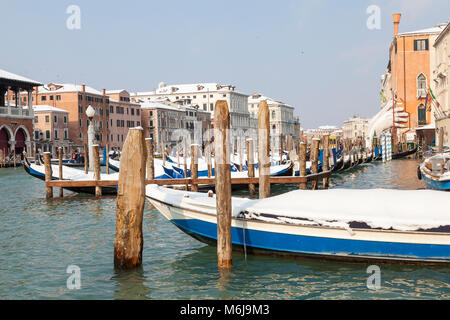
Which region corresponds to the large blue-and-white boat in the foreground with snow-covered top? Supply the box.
[146,185,450,263]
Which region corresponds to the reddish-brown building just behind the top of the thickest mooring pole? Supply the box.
[106,90,141,150]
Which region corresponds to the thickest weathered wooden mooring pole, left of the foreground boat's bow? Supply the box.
[114,128,147,269]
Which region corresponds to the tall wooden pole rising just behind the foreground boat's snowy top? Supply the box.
[258,100,270,199]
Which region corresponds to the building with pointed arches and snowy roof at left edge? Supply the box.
[0,69,42,157]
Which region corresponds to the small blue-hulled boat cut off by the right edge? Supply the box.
[418,152,450,191]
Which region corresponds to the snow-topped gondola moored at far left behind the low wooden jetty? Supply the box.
[23,158,119,195]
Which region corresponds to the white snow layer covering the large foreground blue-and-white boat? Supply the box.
[146,185,450,231]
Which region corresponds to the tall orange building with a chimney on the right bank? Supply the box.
[382,13,445,146]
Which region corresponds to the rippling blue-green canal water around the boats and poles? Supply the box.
[0,160,450,299]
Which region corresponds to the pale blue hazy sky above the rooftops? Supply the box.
[0,0,450,129]
